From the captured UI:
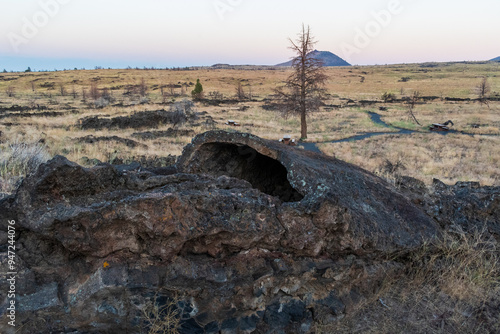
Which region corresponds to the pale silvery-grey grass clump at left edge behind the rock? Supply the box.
[0,142,50,194]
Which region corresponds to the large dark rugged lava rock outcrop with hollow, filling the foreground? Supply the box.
[0,131,438,333]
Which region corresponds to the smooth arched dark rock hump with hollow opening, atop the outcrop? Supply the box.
[177,131,437,251]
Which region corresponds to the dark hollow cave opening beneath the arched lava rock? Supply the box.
[197,143,304,202]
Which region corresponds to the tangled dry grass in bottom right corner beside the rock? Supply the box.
[315,228,500,334]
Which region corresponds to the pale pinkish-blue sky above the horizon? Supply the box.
[0,0,500,71]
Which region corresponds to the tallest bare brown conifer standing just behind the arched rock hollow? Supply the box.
[275,25,328,139]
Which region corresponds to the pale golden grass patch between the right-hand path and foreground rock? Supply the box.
[320,133,500,185]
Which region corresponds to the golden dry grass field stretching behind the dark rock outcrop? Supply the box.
[0,62,500,192]
